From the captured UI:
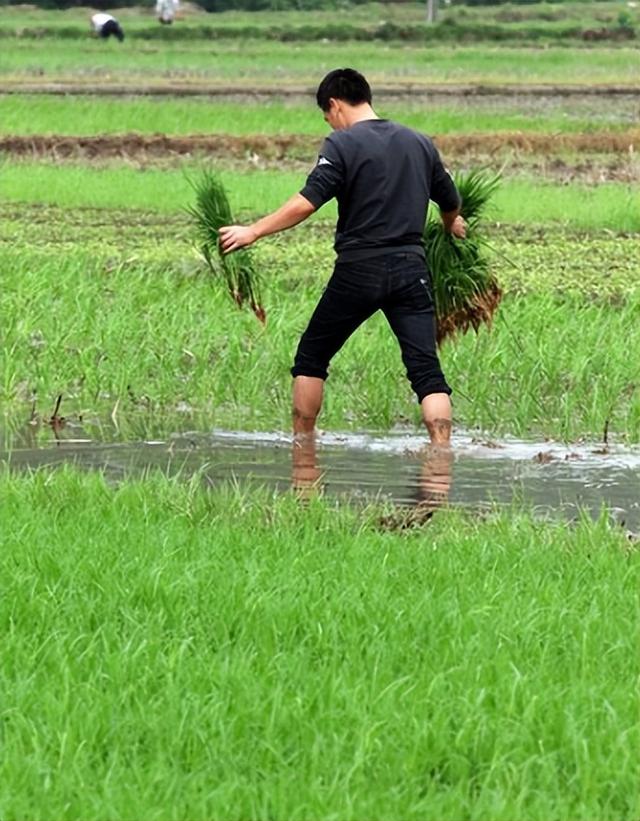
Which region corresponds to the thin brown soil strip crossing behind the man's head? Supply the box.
[2,81,640,99]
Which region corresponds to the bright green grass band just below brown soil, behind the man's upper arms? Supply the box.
[0,158,640,231]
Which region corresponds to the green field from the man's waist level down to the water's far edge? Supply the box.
[0,209,640,442]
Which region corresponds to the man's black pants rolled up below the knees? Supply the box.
[291,253,451,402]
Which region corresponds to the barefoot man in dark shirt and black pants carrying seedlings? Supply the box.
[220,68,465,445]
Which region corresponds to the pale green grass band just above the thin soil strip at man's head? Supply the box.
[0,35,640,90]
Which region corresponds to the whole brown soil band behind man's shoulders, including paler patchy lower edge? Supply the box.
[0,129,640,184]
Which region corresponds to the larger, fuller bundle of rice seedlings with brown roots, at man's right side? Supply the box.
[423,170,502,345]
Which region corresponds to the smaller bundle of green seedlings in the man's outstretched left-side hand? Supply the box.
[187,171,267,323]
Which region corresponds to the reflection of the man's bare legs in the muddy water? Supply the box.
[291,433,453,520]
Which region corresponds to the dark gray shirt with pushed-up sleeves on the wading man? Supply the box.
[300,120,460,262]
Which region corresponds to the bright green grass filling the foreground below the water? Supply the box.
[0,471,640,821]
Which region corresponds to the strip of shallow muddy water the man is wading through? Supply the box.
[0,416,640,533]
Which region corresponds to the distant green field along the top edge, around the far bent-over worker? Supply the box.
[0,0,640,45]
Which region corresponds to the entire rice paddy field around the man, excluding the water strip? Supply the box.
[0,0,640,821]
